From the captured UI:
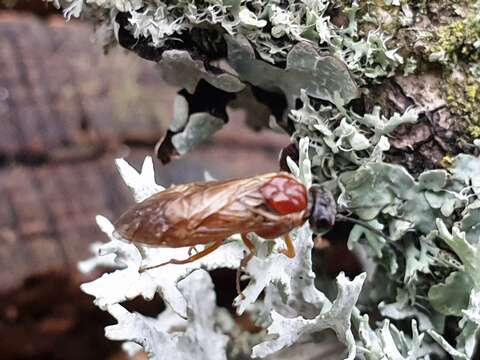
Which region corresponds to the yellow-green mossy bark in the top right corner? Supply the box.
[334,0,480,141]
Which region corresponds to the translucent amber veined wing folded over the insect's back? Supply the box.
[115,173,276,247]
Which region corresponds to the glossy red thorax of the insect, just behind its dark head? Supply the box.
[260,175,307,215]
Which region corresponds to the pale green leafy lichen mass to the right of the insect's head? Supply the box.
[284,93,480,359]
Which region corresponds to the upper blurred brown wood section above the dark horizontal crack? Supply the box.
[0,13,174,160]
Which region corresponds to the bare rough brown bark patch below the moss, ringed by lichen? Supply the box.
[366,68,478,175]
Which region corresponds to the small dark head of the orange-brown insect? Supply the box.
[308,185,337,235]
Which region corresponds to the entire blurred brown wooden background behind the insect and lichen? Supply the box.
[0,9,288,359]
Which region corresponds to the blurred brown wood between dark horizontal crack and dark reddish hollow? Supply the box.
[0,157,131,292]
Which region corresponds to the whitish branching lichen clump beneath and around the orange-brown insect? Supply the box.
[79,144,365,359]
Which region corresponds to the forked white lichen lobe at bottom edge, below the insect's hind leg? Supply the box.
[105,270,228,360]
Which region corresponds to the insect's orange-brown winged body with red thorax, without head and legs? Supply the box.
[115,172,308,247]
